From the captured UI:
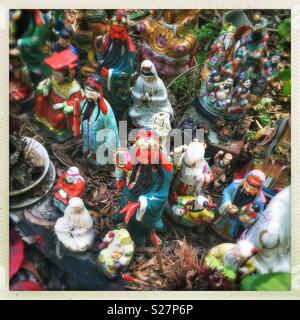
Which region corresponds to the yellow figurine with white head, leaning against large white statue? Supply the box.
[205,240,258,281]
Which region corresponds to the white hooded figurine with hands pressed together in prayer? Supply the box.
[129,60,174,128]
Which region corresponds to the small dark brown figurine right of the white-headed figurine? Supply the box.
[211,150,232,189]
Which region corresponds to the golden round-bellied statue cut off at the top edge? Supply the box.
[138,10,199,76]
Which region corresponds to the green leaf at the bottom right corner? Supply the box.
[241,272,291,291]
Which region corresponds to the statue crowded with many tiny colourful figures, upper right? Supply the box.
[197,10,270,122]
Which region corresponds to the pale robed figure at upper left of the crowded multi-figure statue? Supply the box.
[208,25,236,69]
